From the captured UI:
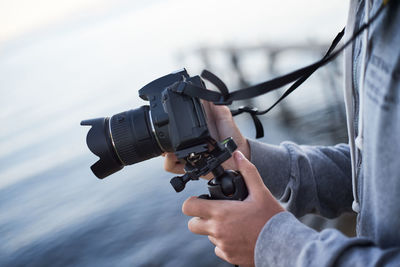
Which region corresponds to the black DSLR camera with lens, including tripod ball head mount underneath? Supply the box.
[81,69,247,200]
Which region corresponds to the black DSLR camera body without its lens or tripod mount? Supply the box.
[139,69,210,158]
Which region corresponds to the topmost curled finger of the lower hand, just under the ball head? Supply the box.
[182,197,223,219]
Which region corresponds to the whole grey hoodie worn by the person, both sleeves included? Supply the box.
[249,0,400,266]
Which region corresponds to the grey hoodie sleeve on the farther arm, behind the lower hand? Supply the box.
[248,140,353,218]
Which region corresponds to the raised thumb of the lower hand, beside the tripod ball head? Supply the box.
[233,151,265,198]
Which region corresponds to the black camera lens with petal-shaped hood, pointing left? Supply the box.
[81,106,162,178]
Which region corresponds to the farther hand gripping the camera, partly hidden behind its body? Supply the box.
[163,101,250,179]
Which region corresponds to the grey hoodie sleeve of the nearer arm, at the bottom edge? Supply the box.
[255,212,400,267]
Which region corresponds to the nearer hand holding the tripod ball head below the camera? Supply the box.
[182,151,284,266]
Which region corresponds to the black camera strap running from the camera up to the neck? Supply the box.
[174,0,390,138]
